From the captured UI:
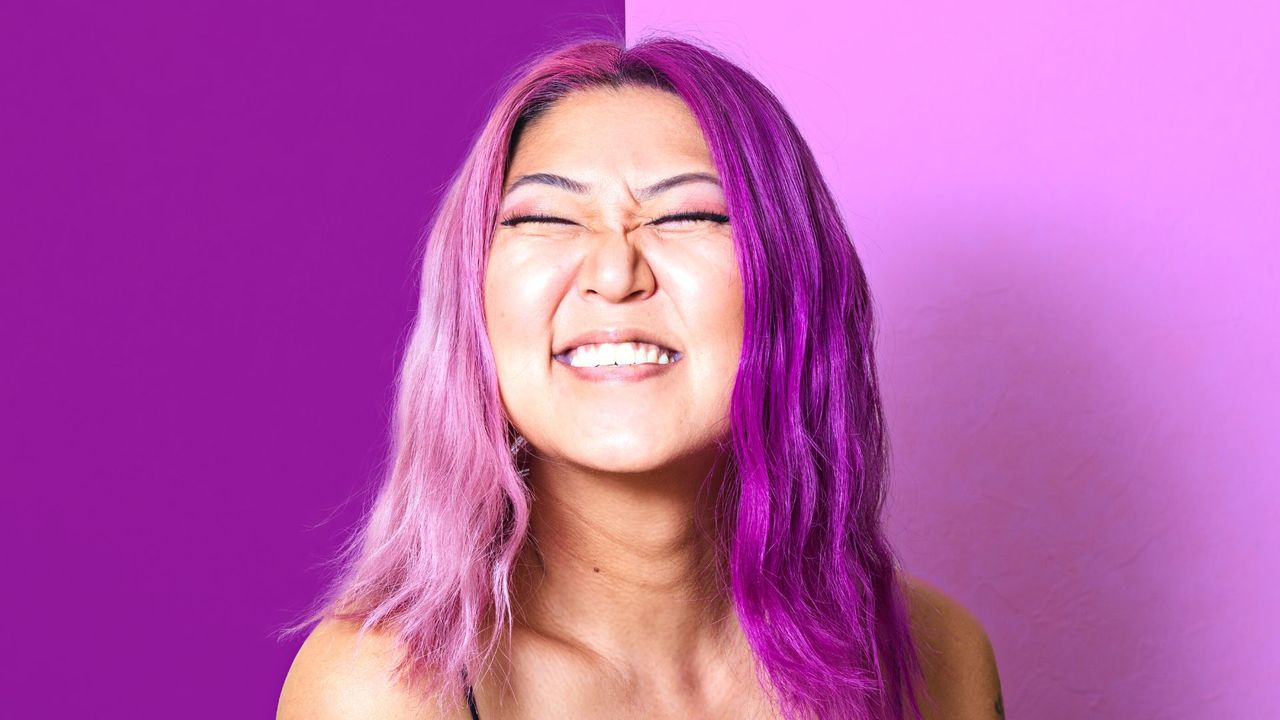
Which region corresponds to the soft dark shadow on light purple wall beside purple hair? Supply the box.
[880,208,1208,720]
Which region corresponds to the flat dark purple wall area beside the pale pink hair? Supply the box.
[0,0,622,719]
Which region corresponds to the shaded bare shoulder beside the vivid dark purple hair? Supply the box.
[904,573,1005,720]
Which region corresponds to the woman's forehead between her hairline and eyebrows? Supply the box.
[508,87,713,177]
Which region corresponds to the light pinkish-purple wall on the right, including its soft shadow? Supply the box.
[626,0,1280,720]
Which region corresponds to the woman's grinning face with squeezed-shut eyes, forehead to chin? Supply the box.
[484,83,742,473]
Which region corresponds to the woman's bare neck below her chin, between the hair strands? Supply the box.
[513,445,736,667]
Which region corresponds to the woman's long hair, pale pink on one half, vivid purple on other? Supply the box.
[282,37,923,720]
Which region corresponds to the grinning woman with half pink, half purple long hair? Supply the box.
[279,38,1001,720]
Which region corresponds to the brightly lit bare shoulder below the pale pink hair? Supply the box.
[275,609,460,720]
